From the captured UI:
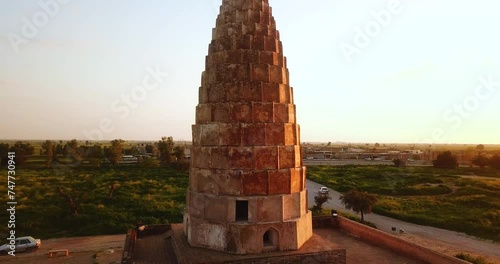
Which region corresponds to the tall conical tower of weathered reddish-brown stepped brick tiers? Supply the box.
[184,0,312,254]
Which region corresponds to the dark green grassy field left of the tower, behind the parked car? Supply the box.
[0,167,188,238]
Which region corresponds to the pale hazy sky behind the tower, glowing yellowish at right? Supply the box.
[0,0,500,144]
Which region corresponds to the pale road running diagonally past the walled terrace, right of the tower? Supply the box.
[306,180,500,263]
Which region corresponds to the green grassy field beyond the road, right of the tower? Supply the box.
[307,166,500,241]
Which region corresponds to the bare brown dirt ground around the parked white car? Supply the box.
[0,235,125,264]
